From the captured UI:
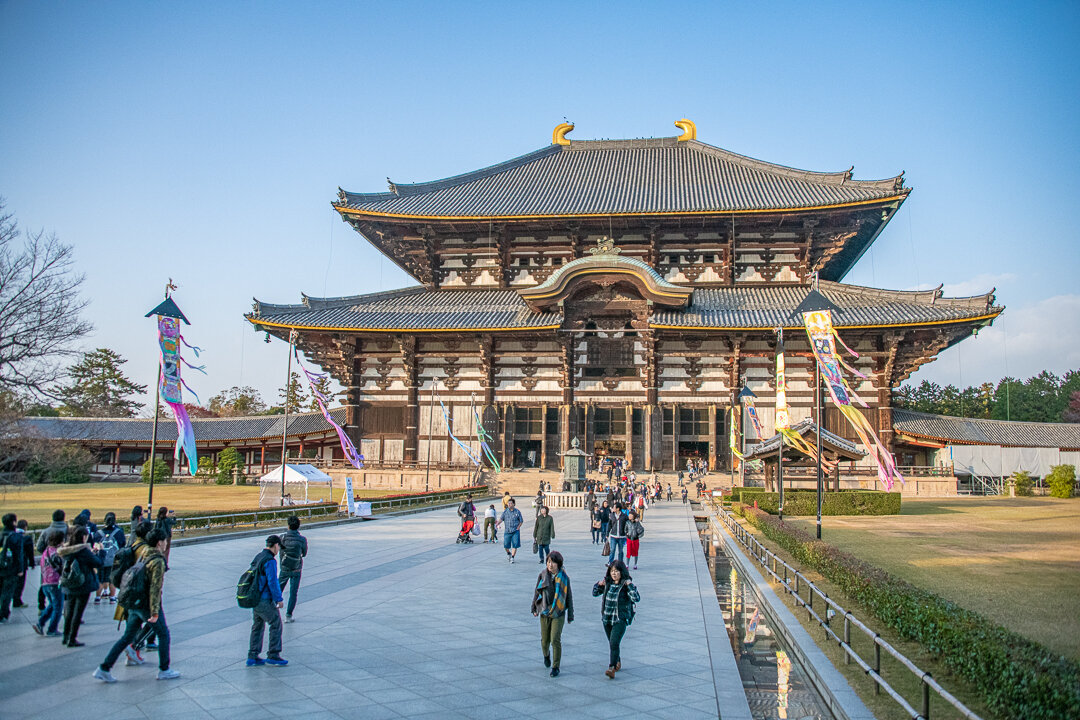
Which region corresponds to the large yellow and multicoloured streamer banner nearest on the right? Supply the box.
[802,310,904,490]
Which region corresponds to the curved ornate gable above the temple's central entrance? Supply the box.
[517,237,693,312]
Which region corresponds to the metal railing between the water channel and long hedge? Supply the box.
[710,500,982,720]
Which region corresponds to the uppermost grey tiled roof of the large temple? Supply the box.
[336,137,907,218]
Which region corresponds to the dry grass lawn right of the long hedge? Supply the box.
[788,498,1080,660]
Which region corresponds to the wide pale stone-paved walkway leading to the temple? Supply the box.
[0,499,748,720]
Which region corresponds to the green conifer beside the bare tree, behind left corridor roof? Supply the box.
[60,348,146,418]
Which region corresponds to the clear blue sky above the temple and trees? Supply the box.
[0,2,1080,410]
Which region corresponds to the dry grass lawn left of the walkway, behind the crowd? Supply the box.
[0,483,391,527]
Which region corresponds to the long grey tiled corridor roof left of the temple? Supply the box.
[21,408,346,444]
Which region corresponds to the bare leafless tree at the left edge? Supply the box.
[0,199,93,397]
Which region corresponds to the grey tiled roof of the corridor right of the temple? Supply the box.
[892,408,1080,450]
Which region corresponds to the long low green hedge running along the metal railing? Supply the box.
[733,499,1080,720]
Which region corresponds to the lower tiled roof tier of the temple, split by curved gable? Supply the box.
[248,281,1001,330]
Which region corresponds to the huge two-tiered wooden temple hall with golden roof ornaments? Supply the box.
[247,121,1001,470]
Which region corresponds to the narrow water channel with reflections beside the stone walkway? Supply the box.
[701,529,834,720]
